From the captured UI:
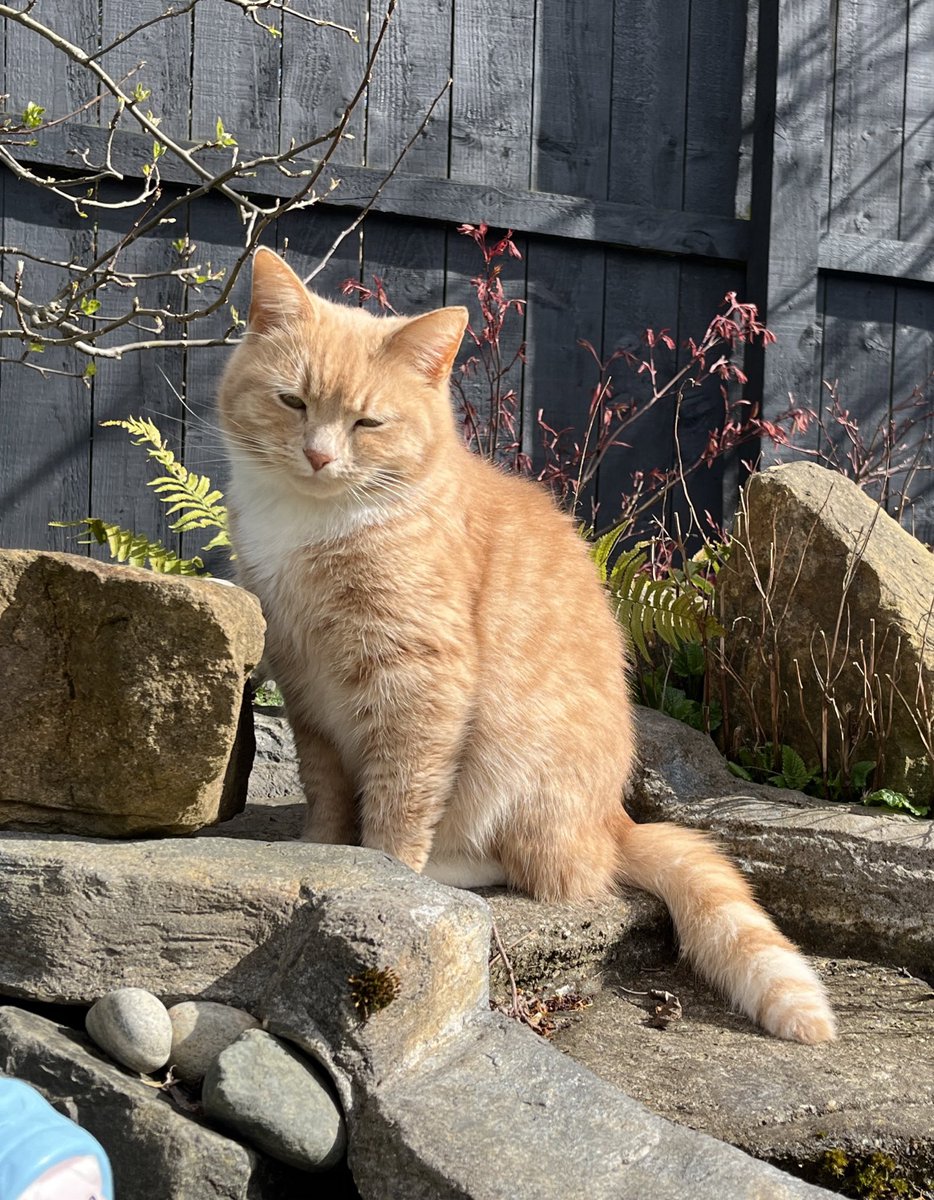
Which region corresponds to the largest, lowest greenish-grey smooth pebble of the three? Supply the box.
[202,1030,347,1171]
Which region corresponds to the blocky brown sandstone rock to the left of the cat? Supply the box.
[0,550,264,836]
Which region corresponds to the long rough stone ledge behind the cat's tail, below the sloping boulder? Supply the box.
[627,708,934,976]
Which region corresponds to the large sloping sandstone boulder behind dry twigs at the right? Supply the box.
[718,462,934,803]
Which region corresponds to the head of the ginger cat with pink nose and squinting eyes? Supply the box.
[218,250,467,500]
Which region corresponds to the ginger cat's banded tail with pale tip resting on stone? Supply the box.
[616,811,836,1043]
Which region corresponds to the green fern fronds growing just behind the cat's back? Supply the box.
[591,526,723,661]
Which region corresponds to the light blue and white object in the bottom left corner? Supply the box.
[0,1075,114,1200]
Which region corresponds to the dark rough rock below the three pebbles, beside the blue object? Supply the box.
[0,1007,307,1200]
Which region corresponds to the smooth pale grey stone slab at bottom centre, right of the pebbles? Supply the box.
[351,1018,831,1200]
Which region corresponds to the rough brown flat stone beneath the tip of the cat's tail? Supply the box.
[553,959,934,1195]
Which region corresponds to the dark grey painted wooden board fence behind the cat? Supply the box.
[0,0,934,550]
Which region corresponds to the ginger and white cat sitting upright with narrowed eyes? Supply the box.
[220,250,834,1043]
